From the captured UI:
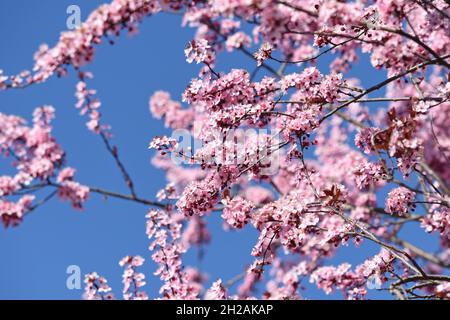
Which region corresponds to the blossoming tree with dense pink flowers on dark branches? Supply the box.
[0,0,450,299]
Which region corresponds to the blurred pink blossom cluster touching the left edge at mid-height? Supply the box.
[0,106,64,227]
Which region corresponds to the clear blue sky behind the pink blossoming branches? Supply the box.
[0,0,438,299]
